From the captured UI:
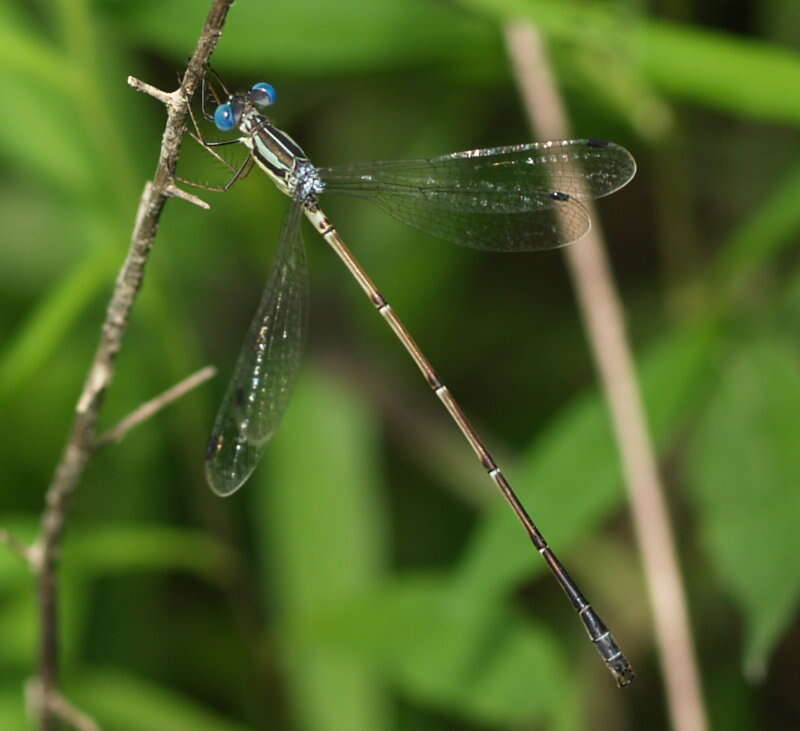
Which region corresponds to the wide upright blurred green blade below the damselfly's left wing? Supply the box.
[258,373,389,731]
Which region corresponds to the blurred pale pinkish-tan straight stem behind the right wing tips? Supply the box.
[506,23,708,731]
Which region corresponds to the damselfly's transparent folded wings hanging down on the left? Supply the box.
[206,203,308,495]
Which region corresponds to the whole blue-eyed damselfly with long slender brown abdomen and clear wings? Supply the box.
[191,76,636,686]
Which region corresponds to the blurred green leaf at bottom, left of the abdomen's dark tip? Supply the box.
[315,576,580,728]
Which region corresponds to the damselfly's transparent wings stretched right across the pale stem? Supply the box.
[319,140,636,251]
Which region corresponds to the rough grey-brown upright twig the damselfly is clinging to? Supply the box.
[39,0,233,731]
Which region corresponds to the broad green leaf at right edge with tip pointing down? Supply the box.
[689,336,800,674]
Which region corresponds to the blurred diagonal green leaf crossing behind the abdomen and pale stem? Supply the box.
[461,320,713,600]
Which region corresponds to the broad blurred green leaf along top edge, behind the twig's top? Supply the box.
[115,0,498,75]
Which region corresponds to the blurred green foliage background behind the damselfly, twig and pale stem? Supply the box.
[0,0,800,731]
